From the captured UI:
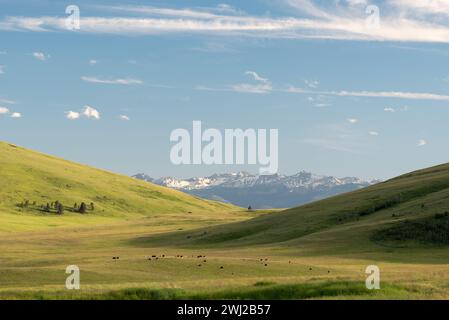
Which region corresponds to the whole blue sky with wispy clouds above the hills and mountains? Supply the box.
[0,0,449,179]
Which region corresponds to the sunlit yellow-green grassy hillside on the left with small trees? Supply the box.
[0,142,239,231]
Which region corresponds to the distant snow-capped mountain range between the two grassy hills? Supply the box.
[133,171,380,208]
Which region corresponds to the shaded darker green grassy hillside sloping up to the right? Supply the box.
[146,164,449,250]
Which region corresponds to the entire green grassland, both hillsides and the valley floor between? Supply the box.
[0,143,449,299]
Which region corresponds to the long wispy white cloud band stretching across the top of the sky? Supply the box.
[0,0,449,43]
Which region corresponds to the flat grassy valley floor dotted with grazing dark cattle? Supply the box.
[0,210,449,299]
